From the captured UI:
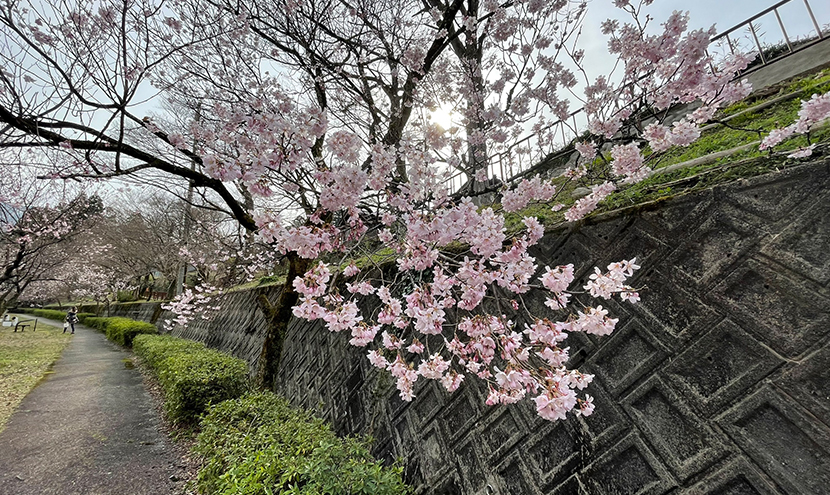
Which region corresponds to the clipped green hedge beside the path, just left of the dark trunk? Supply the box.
[136,336,248,423]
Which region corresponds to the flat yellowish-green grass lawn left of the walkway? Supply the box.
[0,315,72,431]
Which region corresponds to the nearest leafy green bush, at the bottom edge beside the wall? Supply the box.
[194,392,409,495]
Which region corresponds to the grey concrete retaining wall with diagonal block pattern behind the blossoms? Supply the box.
[115,162,830,495]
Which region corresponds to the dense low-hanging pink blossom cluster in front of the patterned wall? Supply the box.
[293,201,639,420]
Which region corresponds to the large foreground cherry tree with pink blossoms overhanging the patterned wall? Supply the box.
[0,0,780,420]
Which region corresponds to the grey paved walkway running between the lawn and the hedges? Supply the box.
[0,319,184,495]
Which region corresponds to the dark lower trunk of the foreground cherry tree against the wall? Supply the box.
[255,253,311,390]
